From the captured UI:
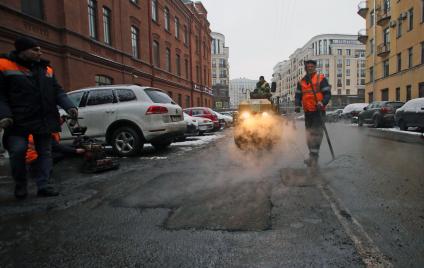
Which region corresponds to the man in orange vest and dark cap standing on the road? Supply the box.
[295,60,331,167]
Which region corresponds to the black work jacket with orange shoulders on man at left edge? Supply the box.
[0,52,75,134]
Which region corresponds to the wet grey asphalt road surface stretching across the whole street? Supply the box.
[0,122,424,267]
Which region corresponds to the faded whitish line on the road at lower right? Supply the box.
[318,183,393,268]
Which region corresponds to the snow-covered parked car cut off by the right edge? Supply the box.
[395,98,424,131]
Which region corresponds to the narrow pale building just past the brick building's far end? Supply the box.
[211,32,230,109]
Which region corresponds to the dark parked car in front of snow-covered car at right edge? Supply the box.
[358,101,405,128]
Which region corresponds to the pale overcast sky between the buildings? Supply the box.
[200,0,365,80]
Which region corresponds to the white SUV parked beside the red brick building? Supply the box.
[62,85,187,156]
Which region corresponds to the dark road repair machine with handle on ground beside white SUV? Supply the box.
[62,115,119,173]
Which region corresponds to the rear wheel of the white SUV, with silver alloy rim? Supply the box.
[110,127,143,156]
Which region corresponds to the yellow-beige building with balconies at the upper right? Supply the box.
[358,0,424,102]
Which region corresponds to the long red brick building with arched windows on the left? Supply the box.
[0,0,213,107]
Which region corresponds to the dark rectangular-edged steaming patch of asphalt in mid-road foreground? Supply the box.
[114,173,272,231]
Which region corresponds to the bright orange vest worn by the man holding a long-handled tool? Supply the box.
[300,73,325,112]
